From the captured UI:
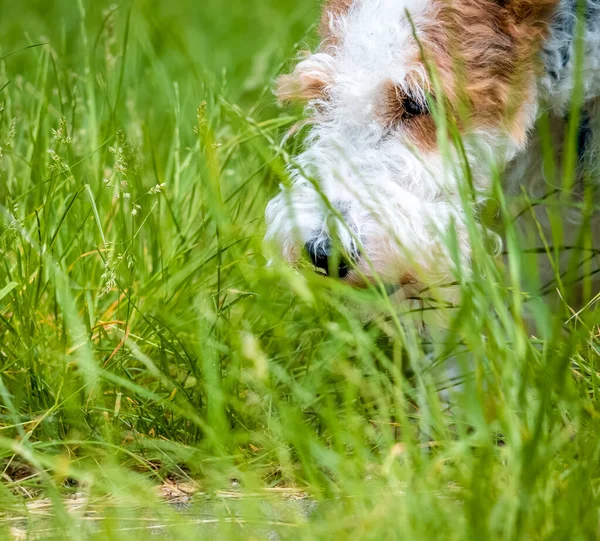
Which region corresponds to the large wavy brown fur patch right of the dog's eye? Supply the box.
[417,0,558,139]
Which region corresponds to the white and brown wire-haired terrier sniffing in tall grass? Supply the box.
[266,0,600,316]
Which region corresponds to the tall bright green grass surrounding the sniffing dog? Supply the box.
[0,0,600,540]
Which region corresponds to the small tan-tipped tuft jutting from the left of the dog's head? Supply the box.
[275,53,334,103]
